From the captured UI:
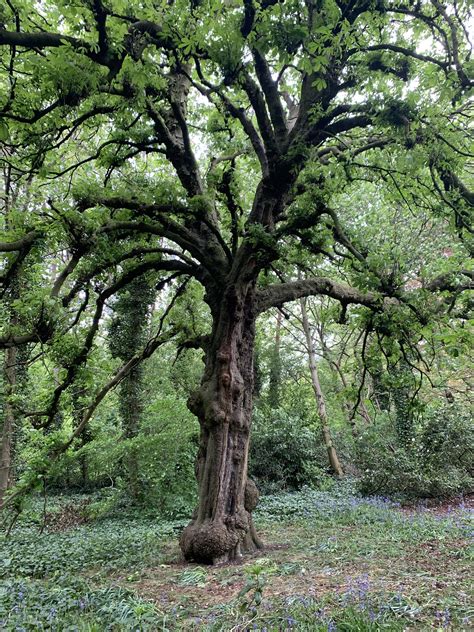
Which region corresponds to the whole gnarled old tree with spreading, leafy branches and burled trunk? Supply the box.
[0,0,474,563]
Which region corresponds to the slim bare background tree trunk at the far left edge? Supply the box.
[0,347,17,509]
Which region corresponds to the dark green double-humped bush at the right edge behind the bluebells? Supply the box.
[356,405,474,498]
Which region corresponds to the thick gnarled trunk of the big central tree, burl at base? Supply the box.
[180,281,262,564]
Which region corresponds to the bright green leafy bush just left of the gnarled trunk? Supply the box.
[48,395,198,519]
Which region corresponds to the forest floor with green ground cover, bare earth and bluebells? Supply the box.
[0,484,474,632]
